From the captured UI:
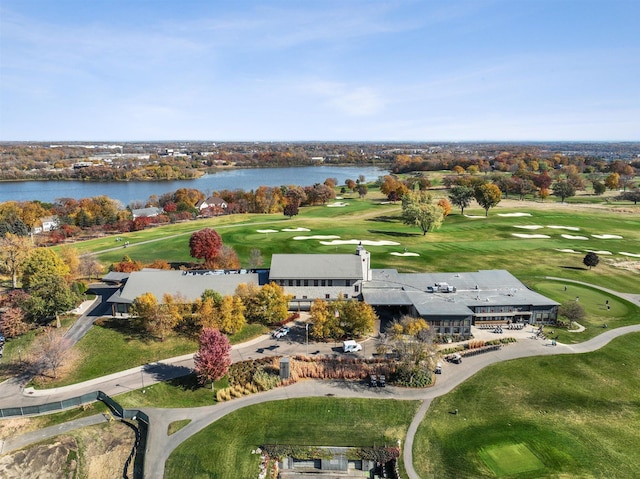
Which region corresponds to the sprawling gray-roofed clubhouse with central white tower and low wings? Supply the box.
[103,245,559,337]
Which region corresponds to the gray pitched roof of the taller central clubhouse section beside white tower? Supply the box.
[269,254,362,280]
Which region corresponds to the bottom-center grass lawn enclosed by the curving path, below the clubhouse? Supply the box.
[165,398,419,479]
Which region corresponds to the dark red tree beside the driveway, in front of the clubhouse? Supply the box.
[193,328,231,389]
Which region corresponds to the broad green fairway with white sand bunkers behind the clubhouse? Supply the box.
[72,198,640,292]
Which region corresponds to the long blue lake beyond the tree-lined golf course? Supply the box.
[0,166,388,206]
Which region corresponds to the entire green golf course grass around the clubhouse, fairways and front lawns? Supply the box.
[21,188,640,479]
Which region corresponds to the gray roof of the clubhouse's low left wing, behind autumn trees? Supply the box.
[109,270,258,303]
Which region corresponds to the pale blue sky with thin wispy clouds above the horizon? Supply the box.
[0,0,640,141]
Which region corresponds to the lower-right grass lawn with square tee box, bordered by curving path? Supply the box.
[414,333,640,479]
